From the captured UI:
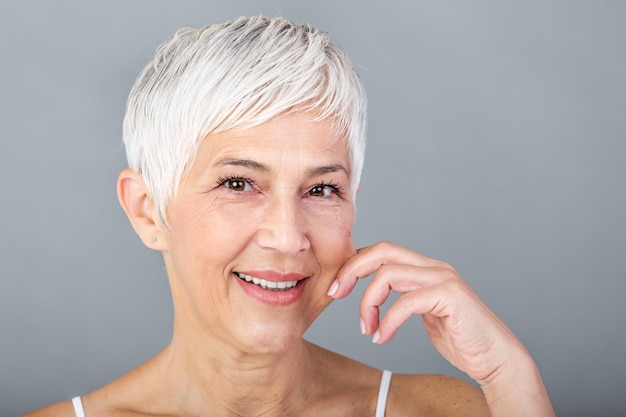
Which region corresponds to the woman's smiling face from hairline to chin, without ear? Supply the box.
[164,113,355,350]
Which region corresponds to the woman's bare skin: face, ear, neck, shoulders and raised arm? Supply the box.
[28,113,553,417]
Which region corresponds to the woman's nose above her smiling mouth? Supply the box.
[256,193,311,255]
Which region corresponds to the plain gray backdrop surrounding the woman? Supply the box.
[0,0,626,417]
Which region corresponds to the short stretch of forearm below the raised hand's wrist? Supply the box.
[481,353,556,417]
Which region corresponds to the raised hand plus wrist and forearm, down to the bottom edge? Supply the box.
[329,242,555,417]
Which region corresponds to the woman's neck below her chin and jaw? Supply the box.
[159,316,319,416]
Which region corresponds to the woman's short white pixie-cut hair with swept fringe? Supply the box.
[123,16,366,226]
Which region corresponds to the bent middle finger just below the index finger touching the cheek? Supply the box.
[360,265,457,334]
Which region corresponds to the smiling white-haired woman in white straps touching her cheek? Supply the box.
[24,17,554,417]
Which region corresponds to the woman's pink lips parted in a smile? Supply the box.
[232,270,309,306]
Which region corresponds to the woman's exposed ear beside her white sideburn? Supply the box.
[117,168,165,250]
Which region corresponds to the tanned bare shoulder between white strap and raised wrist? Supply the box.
[387,374,491,417]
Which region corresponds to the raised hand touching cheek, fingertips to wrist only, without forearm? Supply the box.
[329,242,527,384]
